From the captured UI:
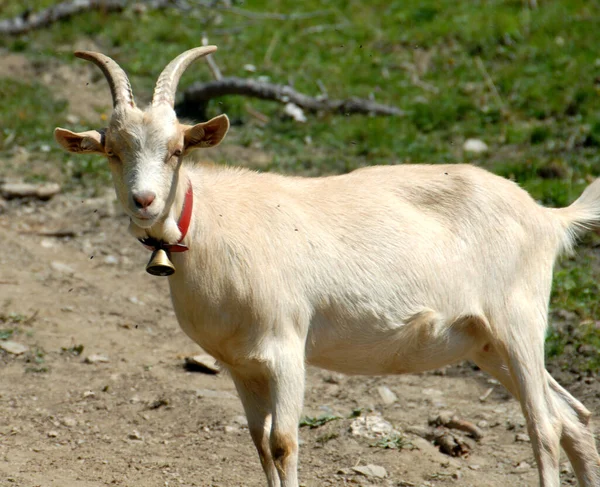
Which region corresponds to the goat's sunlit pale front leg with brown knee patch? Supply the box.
[269,343,304,487]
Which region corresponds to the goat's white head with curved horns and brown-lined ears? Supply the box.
[54,46,229,228]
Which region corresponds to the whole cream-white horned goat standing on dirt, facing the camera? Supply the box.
[55,46,600,487]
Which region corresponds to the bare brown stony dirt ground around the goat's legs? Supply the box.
[0,50,600,487]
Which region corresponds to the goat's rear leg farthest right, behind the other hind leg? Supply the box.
[546,373,600,487]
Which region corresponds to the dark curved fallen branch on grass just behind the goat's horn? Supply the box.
[177,76,404,118]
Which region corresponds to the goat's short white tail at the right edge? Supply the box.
[552,178,600,252]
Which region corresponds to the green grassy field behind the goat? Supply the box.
[0,0,600,370]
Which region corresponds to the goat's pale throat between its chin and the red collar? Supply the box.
[129,167,193,244]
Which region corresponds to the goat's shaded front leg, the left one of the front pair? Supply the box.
[231,371,280,487]
